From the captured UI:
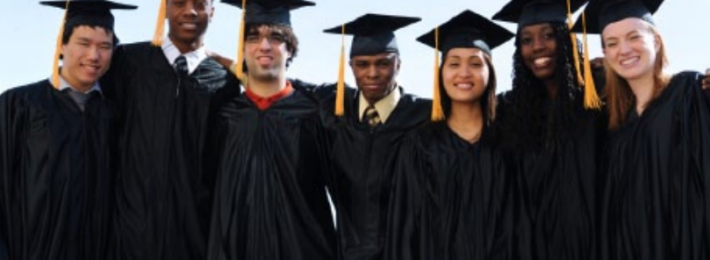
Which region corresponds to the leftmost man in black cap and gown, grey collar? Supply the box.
[0,0,136,260]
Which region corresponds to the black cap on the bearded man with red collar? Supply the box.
[222,0,316,25]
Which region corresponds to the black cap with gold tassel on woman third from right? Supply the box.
[417,10,514,121]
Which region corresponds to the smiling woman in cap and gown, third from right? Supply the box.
[387,10,513,260]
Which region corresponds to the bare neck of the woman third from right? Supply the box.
[446,101,483,143]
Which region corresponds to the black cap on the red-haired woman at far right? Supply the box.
[572,0,663,34]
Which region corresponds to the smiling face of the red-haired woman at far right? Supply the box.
[602,18,660,80]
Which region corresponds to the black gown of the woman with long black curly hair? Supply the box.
[496,90,606,260]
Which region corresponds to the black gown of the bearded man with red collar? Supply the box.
[208,81,336,260]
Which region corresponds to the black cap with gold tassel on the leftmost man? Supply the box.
[40,0,138,88]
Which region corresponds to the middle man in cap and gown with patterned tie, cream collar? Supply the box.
[319,14,431,260]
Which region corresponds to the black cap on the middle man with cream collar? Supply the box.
[324,14,421,57]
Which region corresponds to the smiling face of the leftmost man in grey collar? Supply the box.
[61,25,113,91]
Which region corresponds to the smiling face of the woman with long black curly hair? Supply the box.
[518,23,557,80]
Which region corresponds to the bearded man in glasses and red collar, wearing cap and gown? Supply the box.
[208,0,336,260]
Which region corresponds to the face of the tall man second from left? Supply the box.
[168,0,214,45]
